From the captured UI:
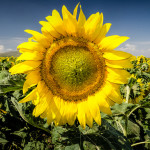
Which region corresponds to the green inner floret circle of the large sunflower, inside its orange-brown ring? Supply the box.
[50,46,97,91]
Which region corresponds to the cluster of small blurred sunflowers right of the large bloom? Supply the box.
[121,56,150,103]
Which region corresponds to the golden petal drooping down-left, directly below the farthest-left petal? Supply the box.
[23,70,41,94]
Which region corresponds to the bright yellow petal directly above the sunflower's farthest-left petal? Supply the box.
[17,51,44,61]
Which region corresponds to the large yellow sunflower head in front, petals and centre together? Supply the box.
[10,4,132,128]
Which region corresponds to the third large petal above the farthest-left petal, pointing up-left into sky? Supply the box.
[25,30,52,48]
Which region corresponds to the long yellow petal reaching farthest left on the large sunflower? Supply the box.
[9,61,41,74]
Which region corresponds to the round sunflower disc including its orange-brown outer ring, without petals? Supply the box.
[41,37,105,101]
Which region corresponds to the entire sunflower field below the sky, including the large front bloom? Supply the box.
[0,3,150,150]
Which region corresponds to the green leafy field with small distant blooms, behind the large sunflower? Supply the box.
[0,56,150,150]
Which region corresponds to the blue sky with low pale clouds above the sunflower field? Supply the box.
[0,0,150,57]
